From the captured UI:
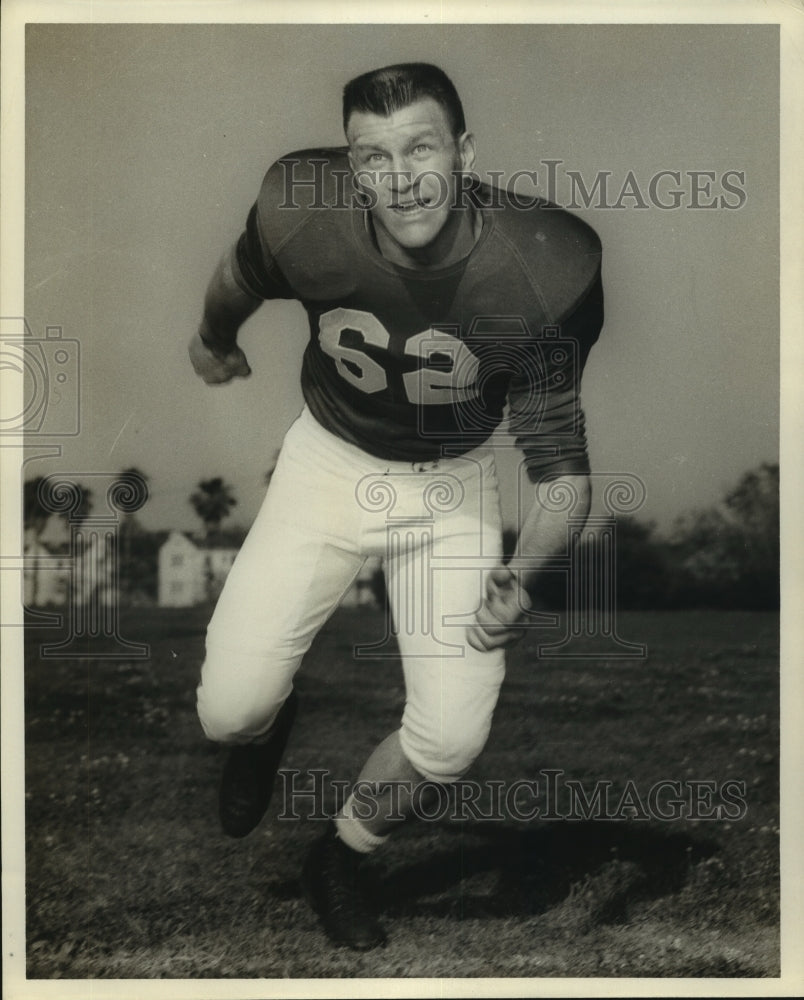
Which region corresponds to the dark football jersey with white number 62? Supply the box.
[232,149,603,481]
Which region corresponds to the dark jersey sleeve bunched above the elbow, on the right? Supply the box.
[508,268,603,483]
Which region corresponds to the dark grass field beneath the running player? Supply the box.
[26,609,779,979]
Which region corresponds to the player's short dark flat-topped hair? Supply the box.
[343,63,466,137]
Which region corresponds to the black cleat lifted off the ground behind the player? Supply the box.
[218,691,298,837]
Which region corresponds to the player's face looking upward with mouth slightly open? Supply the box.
[346,97,474,250]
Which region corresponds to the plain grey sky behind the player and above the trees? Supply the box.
[25,25,779,528]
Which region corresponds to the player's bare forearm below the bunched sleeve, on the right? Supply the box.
[511,475,592,597]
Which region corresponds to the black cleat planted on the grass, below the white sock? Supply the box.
[301,824,387,951]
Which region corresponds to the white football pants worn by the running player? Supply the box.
[198,409,504,782]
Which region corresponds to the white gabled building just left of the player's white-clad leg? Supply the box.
[159,531,238,608]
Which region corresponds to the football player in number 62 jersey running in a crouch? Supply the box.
[190,63,603,949]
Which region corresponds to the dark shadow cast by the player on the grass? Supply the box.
[382,822,718,923]
